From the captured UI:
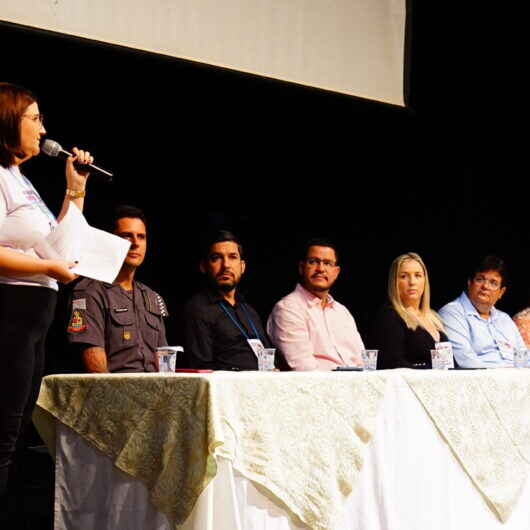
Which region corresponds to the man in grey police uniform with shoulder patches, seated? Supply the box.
[67,206,168,373]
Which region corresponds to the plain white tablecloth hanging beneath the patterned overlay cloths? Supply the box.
[48,376,530,530]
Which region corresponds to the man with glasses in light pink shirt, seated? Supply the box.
[267,239,364,370]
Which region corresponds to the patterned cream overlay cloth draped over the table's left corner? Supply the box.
[38,372,385,530]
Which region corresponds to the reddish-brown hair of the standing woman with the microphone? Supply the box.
[0,83,37,168]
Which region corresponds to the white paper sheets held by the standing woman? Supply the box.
[35,203,131,283]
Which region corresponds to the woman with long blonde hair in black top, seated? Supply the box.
[371,252,447,369]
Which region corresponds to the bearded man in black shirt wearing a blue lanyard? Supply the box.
[184,230,272,370]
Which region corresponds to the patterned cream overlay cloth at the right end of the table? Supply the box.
[398,369,530,522]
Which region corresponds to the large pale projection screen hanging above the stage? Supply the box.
[0,0,406,105]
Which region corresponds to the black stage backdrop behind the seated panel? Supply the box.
[0,1,530,368]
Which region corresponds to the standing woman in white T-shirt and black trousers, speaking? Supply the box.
[0,83,92,504]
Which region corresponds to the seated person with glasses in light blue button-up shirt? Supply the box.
[439,256,525,368]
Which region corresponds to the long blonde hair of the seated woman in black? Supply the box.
[388,252,444,331]
